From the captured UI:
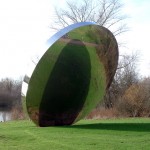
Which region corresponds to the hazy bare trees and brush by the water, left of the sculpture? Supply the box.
[0,78,22,121]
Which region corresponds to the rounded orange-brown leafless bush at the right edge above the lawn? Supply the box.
[117,78,150,117]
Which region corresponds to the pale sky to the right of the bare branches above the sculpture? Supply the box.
[119,0,150,77]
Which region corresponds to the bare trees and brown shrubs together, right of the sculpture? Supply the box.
[89,54,150,118]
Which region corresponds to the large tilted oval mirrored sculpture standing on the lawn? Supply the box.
[23,22,118,127]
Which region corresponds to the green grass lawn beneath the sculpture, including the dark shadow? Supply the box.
[0,118,150,150]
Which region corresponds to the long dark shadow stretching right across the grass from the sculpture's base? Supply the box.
[66,123,150,132]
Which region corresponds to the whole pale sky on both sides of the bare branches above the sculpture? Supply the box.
[0,0,150,79]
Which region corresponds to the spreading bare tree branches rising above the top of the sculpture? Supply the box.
[51,0,128,35]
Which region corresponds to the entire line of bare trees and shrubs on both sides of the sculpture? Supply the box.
[0,53,150,120]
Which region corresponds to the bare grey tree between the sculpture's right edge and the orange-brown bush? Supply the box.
[104,53,139,108]
